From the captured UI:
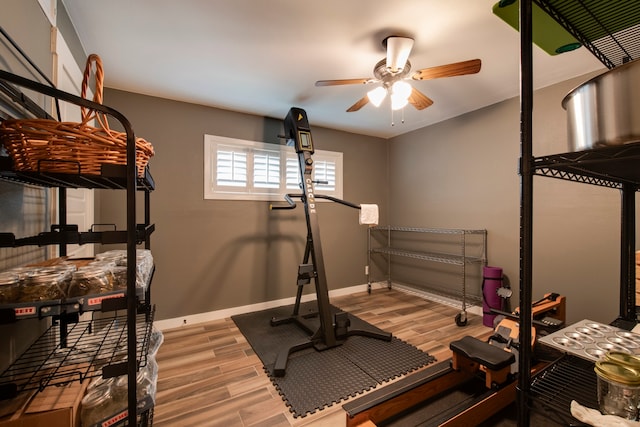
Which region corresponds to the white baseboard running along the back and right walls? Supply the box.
[153,282,482,331]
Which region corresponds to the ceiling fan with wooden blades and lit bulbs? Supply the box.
[316,36,481,113]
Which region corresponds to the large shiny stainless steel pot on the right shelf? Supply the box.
[562,60,640,151]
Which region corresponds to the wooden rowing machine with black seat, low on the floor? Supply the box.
[343,294,566,427]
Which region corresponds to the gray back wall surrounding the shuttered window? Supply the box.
[98,89,388,319]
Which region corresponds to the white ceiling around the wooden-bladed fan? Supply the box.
[63,0,604,138]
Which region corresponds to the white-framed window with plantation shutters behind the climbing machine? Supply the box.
[204,135,342,201]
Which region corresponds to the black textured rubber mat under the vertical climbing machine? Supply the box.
[232,302,435,417]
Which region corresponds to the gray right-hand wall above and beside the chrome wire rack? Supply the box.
[389,72,632,323]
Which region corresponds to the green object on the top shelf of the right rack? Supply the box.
[492,0,581,55]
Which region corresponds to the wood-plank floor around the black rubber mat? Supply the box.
[153,288,491,427]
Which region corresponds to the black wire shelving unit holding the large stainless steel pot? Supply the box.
[517,0,640,426]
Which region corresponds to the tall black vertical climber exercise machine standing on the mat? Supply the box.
[270,107,391,376]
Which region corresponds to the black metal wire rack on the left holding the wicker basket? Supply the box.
[0,51,155,425]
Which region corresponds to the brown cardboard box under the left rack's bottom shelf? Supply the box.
[0,381,89,427]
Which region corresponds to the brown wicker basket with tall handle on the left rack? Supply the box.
[0,54,154,176]
